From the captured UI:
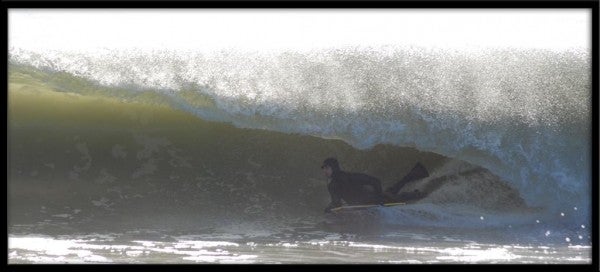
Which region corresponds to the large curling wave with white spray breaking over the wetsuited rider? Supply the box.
[9,48,591,236]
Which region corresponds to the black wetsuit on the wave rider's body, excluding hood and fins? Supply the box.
[325,170,384,212]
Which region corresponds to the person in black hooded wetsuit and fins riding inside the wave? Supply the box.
[321,158,429,213]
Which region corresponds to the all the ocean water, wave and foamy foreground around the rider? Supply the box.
[8,47,591,264]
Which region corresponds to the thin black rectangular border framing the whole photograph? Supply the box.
[1,0,600,271]
